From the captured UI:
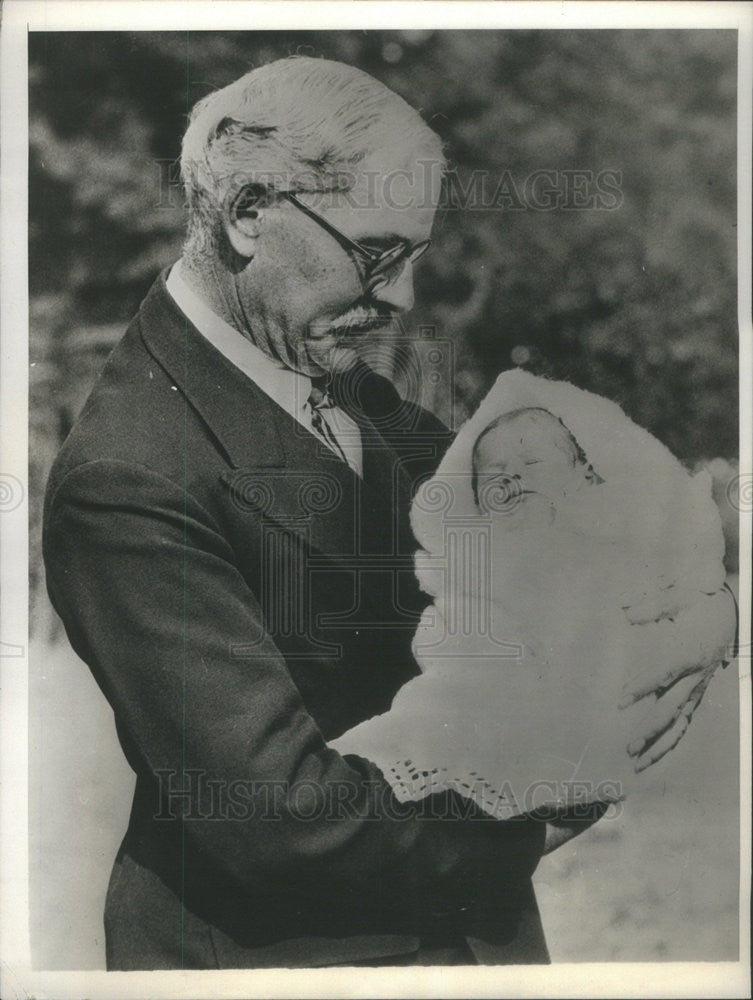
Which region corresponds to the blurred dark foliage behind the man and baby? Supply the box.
[29,30,738,621]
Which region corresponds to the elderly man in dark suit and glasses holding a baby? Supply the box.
[45,58,736,969]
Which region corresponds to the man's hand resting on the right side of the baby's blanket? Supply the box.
[620,590,736,771]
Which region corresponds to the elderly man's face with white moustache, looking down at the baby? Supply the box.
[235,152,441,375]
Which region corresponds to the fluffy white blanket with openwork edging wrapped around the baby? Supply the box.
[333,370,724,818]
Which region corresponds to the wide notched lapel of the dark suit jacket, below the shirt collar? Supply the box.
[140,272,407,556]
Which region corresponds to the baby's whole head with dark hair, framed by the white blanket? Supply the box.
[471,406,604,526]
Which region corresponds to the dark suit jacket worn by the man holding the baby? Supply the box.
[44,275,547,969]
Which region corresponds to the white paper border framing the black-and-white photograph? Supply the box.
[0,0,753,1000]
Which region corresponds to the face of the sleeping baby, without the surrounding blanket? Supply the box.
[476,418,590,511]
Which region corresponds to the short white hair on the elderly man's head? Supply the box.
[181,56,445,260]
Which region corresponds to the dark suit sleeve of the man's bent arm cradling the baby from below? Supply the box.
[44,461,544,921]
